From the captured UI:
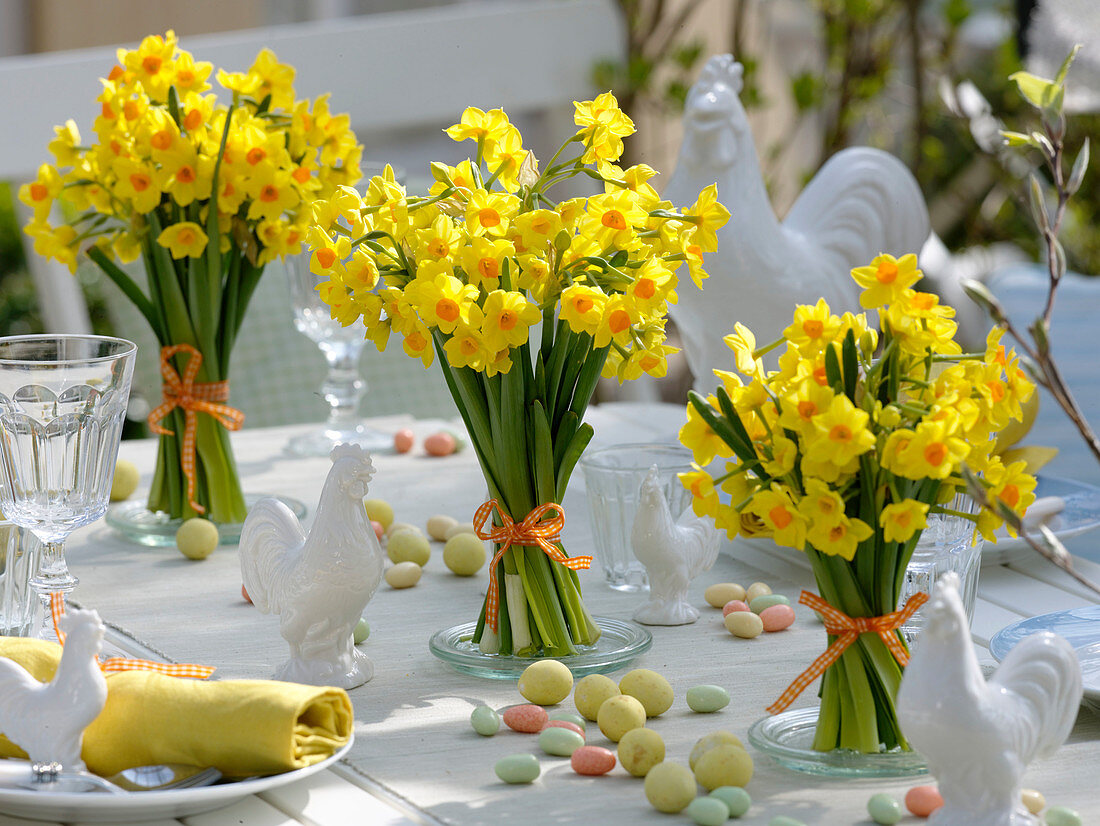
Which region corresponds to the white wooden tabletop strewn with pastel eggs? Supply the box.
[8,405,1100,826]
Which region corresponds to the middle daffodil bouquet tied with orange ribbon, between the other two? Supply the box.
[309,93,728,657]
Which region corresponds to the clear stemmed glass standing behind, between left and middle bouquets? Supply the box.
[287,255,393,456]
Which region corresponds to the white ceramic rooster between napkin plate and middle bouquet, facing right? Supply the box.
[240,444,384,689]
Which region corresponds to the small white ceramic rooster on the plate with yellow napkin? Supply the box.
[0,610,107,771]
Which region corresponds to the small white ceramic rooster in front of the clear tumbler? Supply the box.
[630,464,722,625]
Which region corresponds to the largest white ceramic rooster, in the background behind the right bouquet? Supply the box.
[662,55,928,393]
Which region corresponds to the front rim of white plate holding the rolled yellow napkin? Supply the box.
[0,738,354,823]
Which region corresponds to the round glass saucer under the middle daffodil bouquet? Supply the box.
[428,617,653,680]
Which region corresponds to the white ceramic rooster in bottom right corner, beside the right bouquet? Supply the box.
[898,573,1082,826]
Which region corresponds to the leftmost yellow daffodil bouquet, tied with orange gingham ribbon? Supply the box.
[20,31,362,522]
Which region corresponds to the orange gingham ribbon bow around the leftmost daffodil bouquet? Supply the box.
[149,344,244,514]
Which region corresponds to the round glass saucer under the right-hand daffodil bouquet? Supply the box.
[749,708,928,779]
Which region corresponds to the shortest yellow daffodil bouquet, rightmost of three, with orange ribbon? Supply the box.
[680,255,1035,752]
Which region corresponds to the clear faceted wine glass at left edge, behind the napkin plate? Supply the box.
[0,335,138,638]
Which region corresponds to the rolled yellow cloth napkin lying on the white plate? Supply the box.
[0,637,353,777]
